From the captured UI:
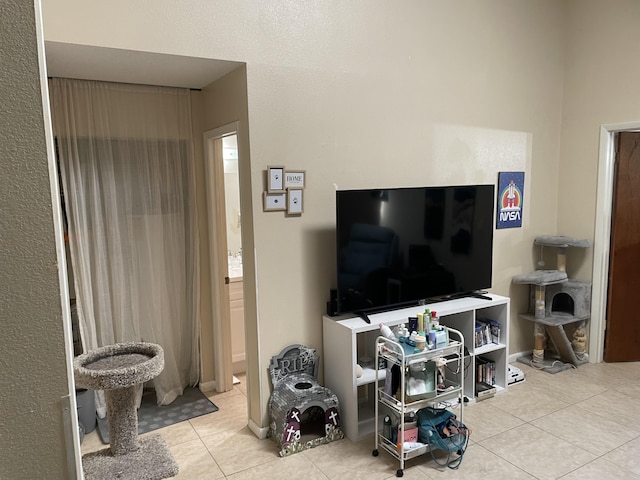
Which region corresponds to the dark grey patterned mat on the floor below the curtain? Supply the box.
[98,387,218,444]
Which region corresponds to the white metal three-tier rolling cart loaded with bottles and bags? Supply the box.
[372,326,467,477]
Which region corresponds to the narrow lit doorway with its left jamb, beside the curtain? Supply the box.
[204,122,246,392]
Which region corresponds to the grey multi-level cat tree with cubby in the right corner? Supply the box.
[513,236,591,373]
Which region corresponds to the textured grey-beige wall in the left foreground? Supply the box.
[0,0,70,479]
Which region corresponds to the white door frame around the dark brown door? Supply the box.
[589,121,640,363]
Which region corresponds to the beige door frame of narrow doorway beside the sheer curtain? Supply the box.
[202,122,240,392]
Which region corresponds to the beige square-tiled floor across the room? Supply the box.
[82,362,640,480]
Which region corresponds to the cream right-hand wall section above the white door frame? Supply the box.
[558,0,640,279]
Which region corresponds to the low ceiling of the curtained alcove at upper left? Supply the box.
[45,42,242,89]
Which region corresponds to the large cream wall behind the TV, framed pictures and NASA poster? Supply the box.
[44,0,564,426]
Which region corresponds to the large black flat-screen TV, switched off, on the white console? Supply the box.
[336,185,495,314]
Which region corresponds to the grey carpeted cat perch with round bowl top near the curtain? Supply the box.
[73,342,178,480]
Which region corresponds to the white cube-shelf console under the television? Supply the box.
[322,294,509,441]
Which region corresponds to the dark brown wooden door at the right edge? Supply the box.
[604,132,640,362]
